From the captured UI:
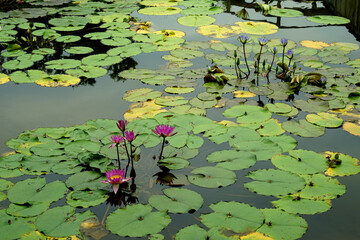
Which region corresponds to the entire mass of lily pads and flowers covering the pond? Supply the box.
[0,0,360,240]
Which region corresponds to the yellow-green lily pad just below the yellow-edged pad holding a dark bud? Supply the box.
[300,174,346,200]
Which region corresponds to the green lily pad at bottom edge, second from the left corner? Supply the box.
[35,206,95,238]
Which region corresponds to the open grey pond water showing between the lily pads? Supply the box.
[0,1,360,240]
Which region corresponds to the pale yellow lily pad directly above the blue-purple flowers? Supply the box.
[234,21,278,35]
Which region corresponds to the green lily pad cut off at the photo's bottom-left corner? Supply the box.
[0,209,35,240]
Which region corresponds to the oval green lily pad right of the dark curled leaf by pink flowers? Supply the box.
[188,167,236,188]
